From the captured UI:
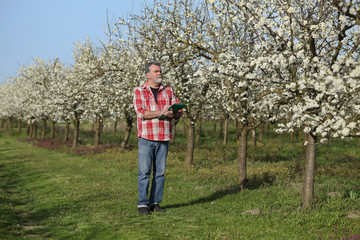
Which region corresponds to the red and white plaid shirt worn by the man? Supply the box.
[133,82,179,141]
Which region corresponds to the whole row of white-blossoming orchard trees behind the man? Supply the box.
[0,0,360,205]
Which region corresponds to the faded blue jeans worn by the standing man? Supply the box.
[137,138,169,207]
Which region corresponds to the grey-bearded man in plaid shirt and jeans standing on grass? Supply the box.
[134,61,181,215]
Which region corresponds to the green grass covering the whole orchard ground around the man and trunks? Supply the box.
[0,125,360,239]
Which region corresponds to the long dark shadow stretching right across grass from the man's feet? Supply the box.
[164,174,275,208]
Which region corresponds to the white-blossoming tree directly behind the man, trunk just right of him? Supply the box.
[121,0,217,164]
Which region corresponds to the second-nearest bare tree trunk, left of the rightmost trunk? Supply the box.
[237,126,249,188]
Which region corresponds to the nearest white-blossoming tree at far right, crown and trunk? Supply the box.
[234,0,360,207]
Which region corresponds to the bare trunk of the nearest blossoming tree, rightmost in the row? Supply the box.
[302,133,317,207]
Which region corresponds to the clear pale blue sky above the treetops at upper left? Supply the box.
[0,0,150,85]
